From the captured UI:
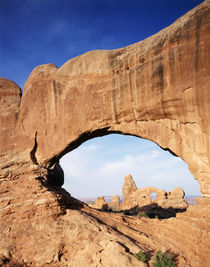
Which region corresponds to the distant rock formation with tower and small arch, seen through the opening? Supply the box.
[93,174,188,218]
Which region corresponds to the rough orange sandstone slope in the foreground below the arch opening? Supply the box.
[0,175,210,267]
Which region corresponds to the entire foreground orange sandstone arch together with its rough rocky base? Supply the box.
[0,0,210,266]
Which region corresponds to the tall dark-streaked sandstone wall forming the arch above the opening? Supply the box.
[0,1,210,196]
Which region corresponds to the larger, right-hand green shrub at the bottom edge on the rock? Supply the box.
[152,250,176,267]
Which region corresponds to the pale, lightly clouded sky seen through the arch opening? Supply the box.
[60,134,200,201]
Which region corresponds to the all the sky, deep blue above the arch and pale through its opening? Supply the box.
[0,0,202,196]
